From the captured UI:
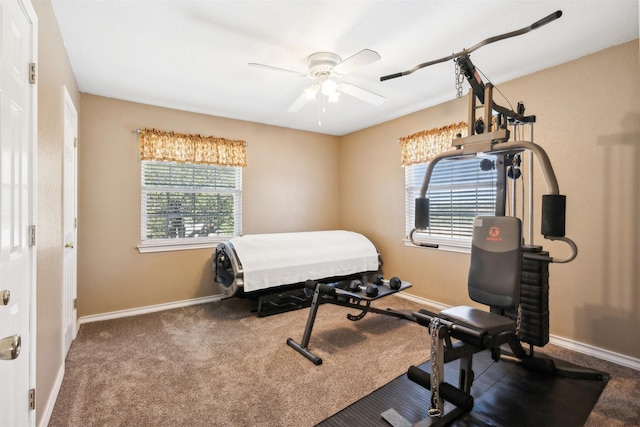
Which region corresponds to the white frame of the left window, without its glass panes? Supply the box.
[137,160,242,253]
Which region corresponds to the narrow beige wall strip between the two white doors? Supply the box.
[33,1,80,424]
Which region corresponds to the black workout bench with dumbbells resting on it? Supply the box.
[287,274,416,365]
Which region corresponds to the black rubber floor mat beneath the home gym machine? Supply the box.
[318,352,609,427]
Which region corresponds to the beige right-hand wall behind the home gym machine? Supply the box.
[340,40,640,358]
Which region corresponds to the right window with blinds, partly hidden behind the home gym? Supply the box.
[405,156,497,251]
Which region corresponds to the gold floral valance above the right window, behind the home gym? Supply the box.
[398,122,468,166]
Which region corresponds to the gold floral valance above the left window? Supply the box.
[140,129,247,166]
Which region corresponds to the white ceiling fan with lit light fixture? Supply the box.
[249,49,385,112]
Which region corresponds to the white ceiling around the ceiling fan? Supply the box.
[52,0,639,137]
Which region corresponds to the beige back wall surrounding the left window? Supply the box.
[78,94,339,316]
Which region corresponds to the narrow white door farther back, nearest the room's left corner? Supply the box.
[62,88,78,357]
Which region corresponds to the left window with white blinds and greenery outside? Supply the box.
[138,160,242,252]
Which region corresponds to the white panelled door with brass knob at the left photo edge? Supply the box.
[0,0,37,427]
